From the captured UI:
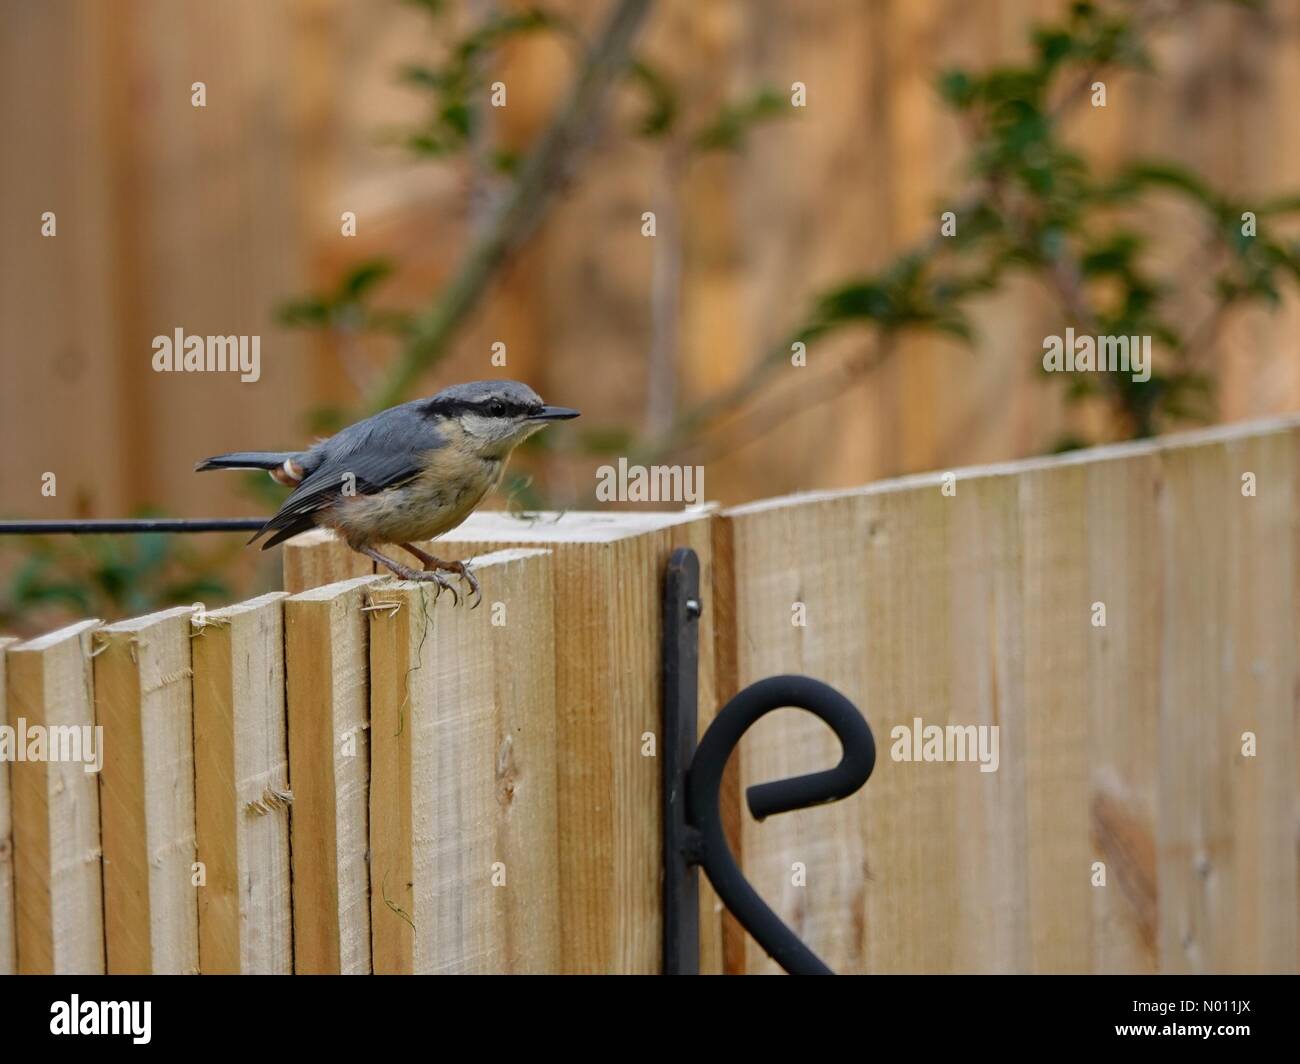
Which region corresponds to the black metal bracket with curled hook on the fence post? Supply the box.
[663,548,876,976]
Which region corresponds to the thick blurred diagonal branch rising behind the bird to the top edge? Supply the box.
[368,0,653,411]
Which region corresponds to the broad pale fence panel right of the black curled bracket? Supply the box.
[719,421,1300,972]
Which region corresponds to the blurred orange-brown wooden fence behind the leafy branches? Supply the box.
[0,0,1300,528]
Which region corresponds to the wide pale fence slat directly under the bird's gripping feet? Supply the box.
[369,550,562,974]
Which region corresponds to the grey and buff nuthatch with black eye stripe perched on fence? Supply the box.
[195,381,577,606]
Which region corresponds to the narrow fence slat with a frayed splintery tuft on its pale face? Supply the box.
[191,592,293,974]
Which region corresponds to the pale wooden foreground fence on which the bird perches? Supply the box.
[0,419,1300,973]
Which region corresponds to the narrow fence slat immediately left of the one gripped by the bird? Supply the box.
[285,576,380,974]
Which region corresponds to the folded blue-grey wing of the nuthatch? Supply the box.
[250,403,443,550]
